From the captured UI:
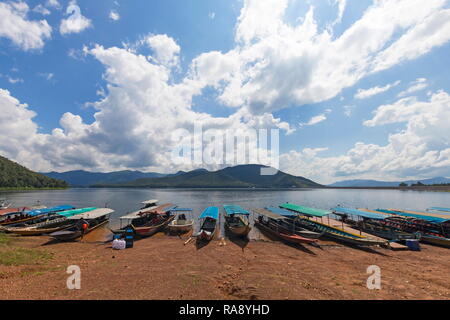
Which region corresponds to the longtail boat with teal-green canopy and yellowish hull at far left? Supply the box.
[4,207,97,236]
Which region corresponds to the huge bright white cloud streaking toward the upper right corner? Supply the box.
[193,0,450,113]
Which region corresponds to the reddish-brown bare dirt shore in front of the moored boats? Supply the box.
[0,229,450,300]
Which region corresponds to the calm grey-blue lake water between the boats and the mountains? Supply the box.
[0,188,450,238]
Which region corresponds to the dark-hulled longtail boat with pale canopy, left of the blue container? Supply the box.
[49,208,114,241]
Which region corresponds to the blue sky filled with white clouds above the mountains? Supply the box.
[0,0,450,183]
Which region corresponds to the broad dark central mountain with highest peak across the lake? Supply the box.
[94,165,321,188]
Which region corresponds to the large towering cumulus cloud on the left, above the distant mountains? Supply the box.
[0,42,292,171]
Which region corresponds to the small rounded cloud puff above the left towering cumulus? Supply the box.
[144,34,180,67]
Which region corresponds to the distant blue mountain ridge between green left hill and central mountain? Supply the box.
[42,170,165,187]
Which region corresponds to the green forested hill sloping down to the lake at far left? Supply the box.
[0,156,68,188]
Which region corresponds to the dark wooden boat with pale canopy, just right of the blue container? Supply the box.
[111,203,176,238]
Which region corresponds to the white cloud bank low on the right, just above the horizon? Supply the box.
[280,91,450,183]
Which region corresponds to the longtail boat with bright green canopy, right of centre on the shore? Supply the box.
[280,203,387,246]
